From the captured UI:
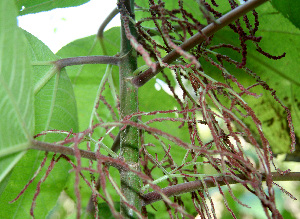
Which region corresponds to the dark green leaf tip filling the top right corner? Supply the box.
[271,0,300,29]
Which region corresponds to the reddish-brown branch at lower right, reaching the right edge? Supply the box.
[142,172,300,206]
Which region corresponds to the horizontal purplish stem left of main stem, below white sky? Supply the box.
[53,56,120,70]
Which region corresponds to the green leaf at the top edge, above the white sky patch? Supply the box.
[15,0,89,15]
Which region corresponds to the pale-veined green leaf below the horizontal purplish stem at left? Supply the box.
[25,32,78,138]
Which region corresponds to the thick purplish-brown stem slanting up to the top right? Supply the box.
[132,0,268,87]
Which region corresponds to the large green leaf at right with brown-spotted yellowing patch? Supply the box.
[249,3,300,153]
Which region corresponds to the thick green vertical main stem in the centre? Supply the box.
[120,0,141,218]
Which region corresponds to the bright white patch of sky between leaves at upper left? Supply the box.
[18,0,120,53]
